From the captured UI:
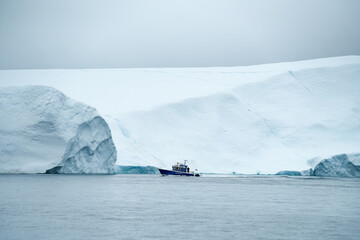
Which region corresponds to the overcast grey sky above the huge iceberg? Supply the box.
[0,0,360,69]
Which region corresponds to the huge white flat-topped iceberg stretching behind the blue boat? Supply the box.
[0,56,360,173]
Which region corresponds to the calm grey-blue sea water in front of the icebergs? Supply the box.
[0,175,360,240]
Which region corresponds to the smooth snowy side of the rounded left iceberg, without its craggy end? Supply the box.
[0,86,116,173]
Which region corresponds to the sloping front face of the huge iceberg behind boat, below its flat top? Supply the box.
[110,64,360,174]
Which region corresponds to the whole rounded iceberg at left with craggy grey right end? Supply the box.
[0,86,116,173]
